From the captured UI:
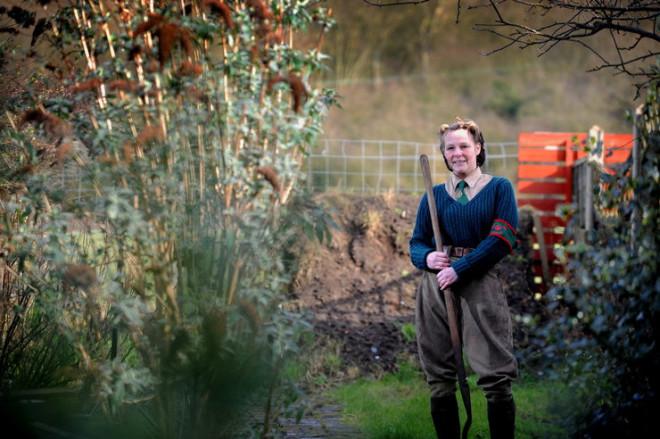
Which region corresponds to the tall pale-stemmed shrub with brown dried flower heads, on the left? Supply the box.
[0,0,334,437]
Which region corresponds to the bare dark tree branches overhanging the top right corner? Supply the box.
[363,0,660,91]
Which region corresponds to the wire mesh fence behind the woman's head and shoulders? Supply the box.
[304,139,518,193]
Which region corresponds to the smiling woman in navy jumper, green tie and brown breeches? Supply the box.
[410,118,518,439]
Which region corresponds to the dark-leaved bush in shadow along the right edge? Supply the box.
[533,85,660,437]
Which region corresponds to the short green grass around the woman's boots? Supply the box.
[331,363,568,439]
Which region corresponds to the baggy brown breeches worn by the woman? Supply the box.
[415,270,518,402]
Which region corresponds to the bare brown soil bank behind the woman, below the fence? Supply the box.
[294,194,542,373]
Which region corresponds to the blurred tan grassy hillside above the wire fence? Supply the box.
[309,0,635,143]
